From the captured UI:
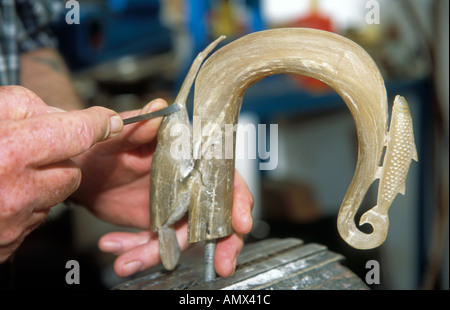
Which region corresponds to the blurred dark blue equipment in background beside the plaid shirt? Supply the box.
[53,0,173,71]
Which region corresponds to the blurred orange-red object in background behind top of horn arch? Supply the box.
[293,0,334,92]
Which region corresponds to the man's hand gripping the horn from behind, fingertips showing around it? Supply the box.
[74,99,253,277]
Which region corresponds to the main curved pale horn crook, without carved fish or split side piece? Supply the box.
[189,28,387,247]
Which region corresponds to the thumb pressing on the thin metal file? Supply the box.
[10,107,123,166]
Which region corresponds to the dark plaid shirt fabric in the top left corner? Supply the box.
[0,0,64,85]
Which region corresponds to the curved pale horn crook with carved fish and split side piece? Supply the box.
[150,28,417,269]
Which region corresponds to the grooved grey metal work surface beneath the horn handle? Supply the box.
[114,238,369,290]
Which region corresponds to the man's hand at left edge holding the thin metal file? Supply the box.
[0,86,123,263]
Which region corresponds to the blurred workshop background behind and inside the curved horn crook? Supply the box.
[9,0,449,289]
